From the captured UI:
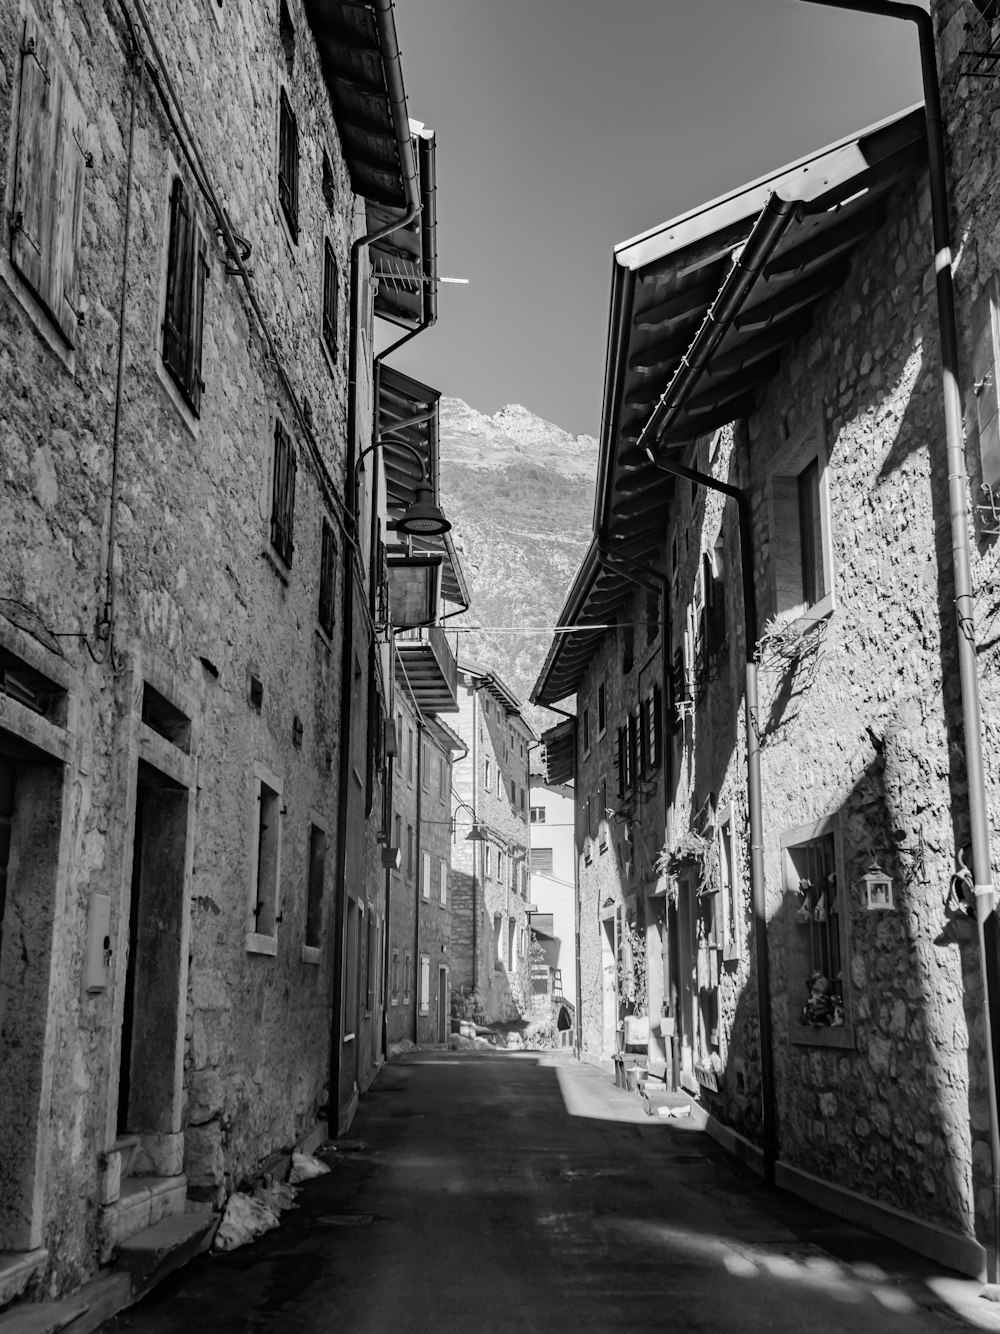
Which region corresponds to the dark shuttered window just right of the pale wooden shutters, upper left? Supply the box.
[161,176,208,416]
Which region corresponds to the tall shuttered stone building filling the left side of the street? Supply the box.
[0,0,443,1305]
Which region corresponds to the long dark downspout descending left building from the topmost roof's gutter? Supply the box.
[329,0,420,1119]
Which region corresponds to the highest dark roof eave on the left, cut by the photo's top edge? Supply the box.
[305,0,415,211]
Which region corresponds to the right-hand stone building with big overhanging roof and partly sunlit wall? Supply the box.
[541,86,1000,1273]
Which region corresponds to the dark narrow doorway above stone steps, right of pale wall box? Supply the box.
[117,763,189,1161]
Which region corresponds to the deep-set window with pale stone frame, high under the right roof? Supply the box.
[768,426,833,619]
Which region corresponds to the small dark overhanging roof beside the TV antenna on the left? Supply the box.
[368,121,437,329]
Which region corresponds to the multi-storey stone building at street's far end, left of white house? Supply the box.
[452,662,537,1023]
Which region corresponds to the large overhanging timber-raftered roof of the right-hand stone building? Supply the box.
[531,107,927,704]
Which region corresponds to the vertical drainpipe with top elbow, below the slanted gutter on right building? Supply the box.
[645,459,777,1186]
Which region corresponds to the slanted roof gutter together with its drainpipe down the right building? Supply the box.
[637,193,801,1186]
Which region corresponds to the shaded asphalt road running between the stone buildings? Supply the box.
[105,1051,1000,1334]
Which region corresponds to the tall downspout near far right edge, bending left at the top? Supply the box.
[809,0,1000,1283]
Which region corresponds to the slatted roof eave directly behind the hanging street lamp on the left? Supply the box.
[379,362,469,607]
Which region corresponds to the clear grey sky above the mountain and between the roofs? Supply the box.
[381,0,920,435]
